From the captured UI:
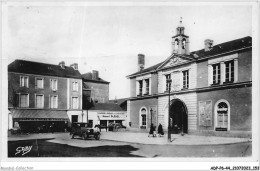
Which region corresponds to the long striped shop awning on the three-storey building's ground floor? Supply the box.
[11,109,69,121]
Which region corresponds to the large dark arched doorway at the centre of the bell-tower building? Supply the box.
[170,99,188,134]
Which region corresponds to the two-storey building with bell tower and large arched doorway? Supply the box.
[127,20,252,136]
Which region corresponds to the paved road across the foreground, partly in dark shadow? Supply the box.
[8,135,252,158]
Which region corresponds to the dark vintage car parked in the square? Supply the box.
[70,122,101,140]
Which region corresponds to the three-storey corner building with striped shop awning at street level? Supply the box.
[8,60,82,132]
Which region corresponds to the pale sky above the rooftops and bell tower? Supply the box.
[3,3,252,99]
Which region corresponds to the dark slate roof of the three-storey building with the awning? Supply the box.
[8,59,81,79]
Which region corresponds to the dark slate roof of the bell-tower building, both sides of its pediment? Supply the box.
[127,36,252,78]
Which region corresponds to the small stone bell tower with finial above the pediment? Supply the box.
[172,17,189,55]
